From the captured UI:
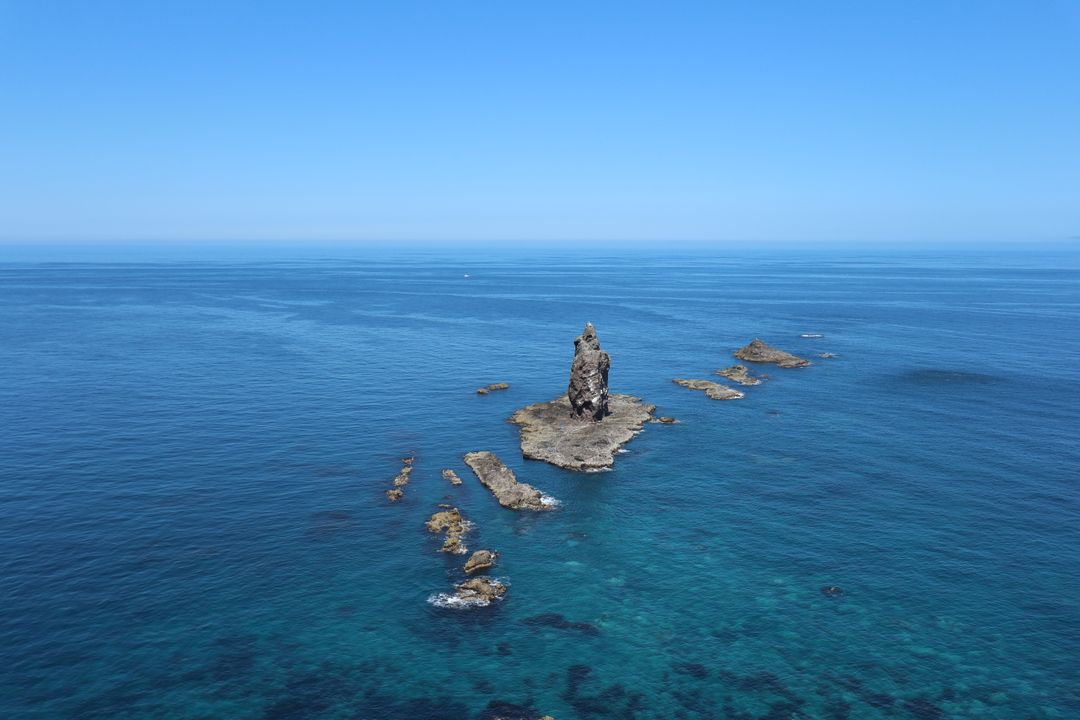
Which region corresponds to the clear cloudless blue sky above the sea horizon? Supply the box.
[0,0,1080,245]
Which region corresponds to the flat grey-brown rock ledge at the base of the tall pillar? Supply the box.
[510,395,656,471]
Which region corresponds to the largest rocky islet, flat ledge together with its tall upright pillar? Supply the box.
[510,323,656,472]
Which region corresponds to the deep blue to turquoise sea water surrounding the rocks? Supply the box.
[0,250,1080,720]
